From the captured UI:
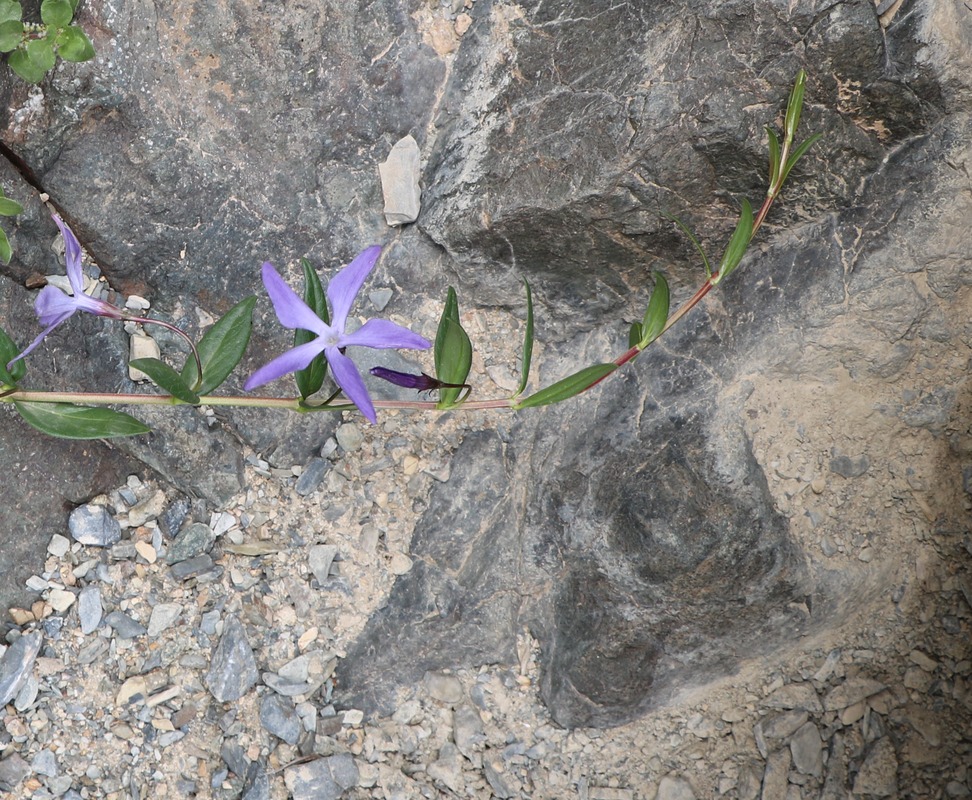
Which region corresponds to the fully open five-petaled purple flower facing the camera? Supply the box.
[243,246,432,422]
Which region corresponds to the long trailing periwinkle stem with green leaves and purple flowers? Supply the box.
[0,72,819,439]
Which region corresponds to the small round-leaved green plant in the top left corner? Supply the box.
[0,0,94,83]
